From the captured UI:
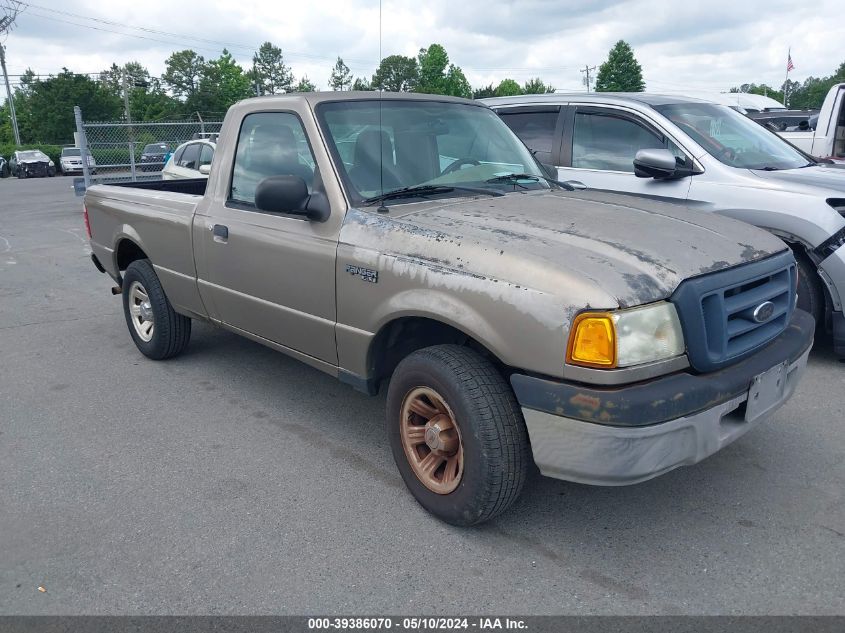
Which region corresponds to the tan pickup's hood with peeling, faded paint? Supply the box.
[357,191,786,308]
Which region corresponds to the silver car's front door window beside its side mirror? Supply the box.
[572,112,664,173]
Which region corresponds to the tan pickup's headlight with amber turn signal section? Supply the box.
[566,301,684,369]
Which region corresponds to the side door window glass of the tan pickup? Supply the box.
[229,112,315,205]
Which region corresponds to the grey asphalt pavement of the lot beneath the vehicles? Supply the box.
[0,177,845,615]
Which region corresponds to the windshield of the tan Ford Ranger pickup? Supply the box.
[317,99,549,203]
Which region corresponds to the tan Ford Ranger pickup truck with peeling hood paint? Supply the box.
[85,92,814,525]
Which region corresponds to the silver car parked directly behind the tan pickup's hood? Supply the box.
[485,93,845,357]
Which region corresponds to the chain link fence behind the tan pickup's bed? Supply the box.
[74,107,223,188]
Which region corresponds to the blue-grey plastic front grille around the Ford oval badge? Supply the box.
[672,251,797,371]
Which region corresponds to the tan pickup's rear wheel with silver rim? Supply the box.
[123,259,191,360]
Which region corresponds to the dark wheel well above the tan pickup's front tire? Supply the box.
[368,317,505,385]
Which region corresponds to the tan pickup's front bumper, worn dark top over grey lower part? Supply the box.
[511,310,815,486]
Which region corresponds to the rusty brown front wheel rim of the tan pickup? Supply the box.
[400,387,464,495]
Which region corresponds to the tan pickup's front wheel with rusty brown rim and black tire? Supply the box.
[387,345,531,526]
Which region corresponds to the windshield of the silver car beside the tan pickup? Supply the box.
[654,103,808,170]
